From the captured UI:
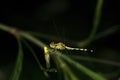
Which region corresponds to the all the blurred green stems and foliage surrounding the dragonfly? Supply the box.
[0,0,120,80]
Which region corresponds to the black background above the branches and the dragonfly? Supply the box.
[0,0,120,39]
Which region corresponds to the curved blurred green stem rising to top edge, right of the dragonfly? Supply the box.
[78,0,103,47]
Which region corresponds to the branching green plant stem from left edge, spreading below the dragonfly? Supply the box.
[0,24,106,80]
